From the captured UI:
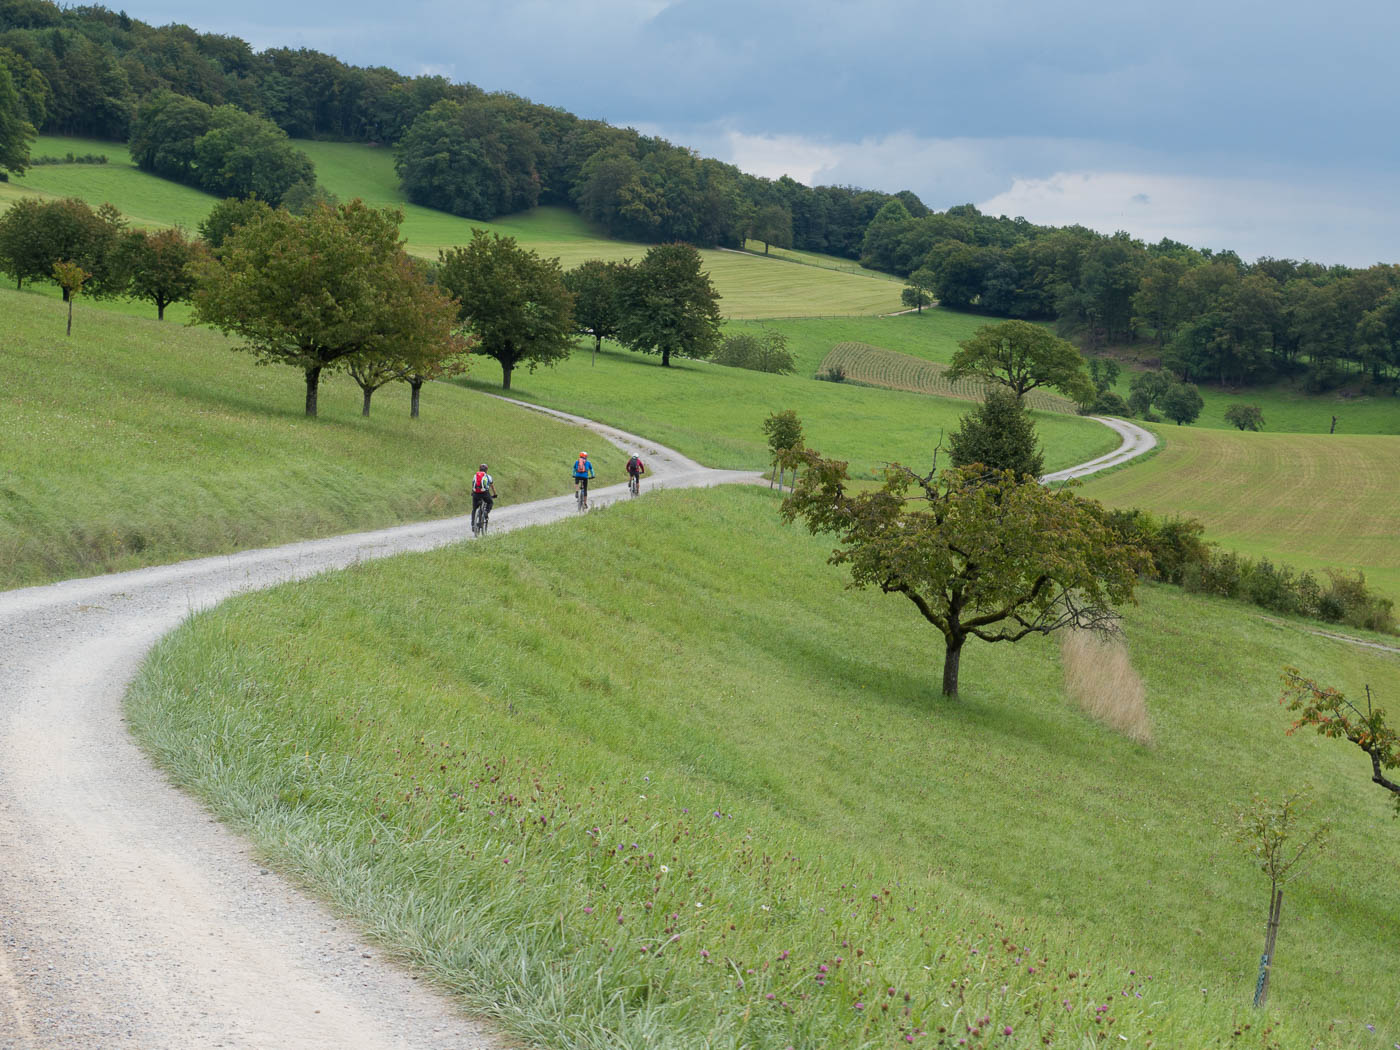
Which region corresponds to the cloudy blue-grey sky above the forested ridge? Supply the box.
[127,0,1400,266]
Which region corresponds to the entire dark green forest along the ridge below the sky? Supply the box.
[0,0,1400,393]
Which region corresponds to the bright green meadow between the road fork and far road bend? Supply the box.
[469,340,1119,476]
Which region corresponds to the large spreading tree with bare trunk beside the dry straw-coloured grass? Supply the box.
[783,451,1151,696]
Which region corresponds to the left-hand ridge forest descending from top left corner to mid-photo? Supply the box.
[0,0,927,259]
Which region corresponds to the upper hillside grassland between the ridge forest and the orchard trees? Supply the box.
[0,136,902,318]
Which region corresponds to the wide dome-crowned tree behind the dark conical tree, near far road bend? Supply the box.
[948,321,1093,403]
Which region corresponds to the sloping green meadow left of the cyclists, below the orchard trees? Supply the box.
[0,291,623,588]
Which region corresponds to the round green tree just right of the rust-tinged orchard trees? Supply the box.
[438,230,574,391]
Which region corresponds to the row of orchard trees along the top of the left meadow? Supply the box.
[0,197,739,417]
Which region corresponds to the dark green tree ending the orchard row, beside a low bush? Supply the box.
[619,244,721,368]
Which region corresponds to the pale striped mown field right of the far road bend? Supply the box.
[1084,424,1400,602]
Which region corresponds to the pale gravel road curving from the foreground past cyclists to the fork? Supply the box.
[0,406,1151,1050]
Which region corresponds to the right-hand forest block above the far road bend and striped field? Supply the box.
[861,202,1400,391]
